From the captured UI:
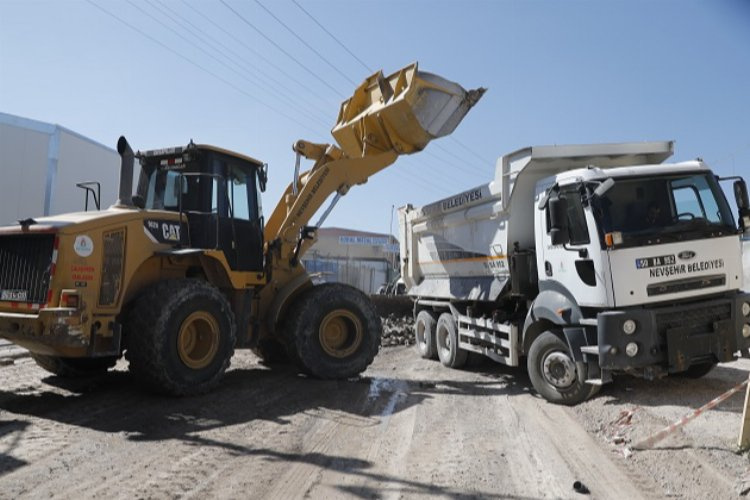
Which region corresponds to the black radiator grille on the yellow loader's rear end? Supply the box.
[0,234,55,304]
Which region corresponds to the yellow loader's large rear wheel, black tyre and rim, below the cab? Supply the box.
[125,279,236,395]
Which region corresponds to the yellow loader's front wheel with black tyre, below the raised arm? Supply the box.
[286,283,383,379]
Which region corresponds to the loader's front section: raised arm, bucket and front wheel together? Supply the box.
[256,63,485,378]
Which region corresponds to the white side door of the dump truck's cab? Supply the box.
[537,184,610,307]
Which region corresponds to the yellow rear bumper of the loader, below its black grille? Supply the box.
[0,307,90,357]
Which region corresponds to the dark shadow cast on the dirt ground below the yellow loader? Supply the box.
[0,356,529,498]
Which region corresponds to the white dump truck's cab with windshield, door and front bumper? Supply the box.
[536,161,748,381]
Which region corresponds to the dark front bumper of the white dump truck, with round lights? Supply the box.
[597,293,750,373]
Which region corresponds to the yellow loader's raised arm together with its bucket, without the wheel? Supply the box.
[264,63,485,289]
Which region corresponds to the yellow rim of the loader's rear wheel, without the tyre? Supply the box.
[177,311,220,370]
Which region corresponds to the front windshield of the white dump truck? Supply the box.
[594,173,736,245]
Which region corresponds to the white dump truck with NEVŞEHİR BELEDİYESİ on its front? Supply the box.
[399,142,750,405]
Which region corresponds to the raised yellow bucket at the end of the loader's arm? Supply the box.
[331,63,485,158]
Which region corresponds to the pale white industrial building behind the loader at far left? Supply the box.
[0,113,120,224]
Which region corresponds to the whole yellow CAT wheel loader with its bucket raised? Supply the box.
[0,64,484,395]
